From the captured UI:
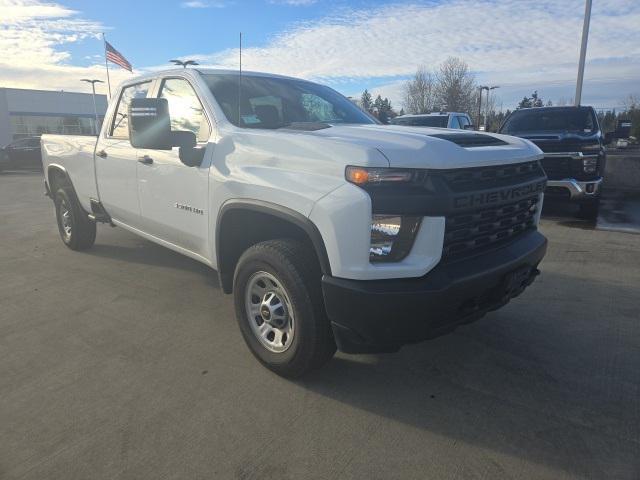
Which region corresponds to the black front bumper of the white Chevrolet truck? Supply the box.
[322,231,547,353]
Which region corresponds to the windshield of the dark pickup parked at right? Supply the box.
[500,107,597,134]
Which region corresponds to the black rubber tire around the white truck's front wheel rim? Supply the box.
[233,239,336,378]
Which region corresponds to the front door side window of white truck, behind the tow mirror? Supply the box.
[160,78,211,142]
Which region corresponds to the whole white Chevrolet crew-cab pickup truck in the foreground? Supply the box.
[42,69,547,377]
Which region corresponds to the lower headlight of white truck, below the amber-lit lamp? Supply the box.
[369,215,422,262]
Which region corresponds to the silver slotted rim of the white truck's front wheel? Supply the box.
[245,272,295,353]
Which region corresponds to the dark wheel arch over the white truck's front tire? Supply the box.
[215,200,331,293]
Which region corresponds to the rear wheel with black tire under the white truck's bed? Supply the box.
[54,187,96,250]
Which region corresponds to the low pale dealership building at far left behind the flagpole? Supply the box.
[0,88,107,147]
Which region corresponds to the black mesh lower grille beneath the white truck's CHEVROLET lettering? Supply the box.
[442,195,539,261]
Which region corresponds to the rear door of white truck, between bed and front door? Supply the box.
[96,80,152,228]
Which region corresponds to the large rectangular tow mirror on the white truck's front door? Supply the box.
[128,98,172,150]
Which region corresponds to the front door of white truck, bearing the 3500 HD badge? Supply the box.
[137,77,212,258]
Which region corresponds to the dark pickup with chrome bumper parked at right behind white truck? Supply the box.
[500,106,606,219]
